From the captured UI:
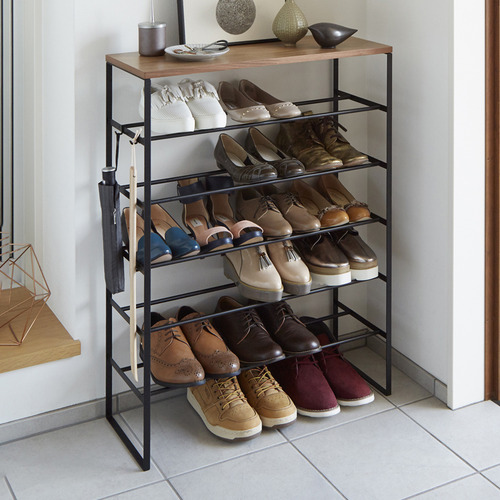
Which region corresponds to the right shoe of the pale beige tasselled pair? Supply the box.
[267,241,312,295]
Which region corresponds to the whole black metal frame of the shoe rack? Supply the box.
[106,53,392,470]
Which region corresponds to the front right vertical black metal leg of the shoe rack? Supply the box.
[385,54,392,395]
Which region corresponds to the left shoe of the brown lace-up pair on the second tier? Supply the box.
[276,120,342,172]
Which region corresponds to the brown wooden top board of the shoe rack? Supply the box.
[106,36,392,80]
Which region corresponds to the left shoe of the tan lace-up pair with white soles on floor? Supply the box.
[187,377,262,441]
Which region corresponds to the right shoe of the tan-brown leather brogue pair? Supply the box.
[177,306,240,377]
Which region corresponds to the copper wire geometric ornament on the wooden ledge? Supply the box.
[0,233,50,346]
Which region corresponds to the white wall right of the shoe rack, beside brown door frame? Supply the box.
[360,0,484,408]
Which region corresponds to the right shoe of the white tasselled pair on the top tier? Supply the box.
[179,78,227,130]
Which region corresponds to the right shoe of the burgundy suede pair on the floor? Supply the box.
[300,317,375,406]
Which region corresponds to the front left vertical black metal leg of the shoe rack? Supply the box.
[142,79,151,470]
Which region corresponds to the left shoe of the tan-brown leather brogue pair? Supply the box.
[141,313,205,387]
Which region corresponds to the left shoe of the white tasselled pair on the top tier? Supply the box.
[139,84,194,134]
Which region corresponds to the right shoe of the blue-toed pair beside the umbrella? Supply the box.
[151,205,200,259]
